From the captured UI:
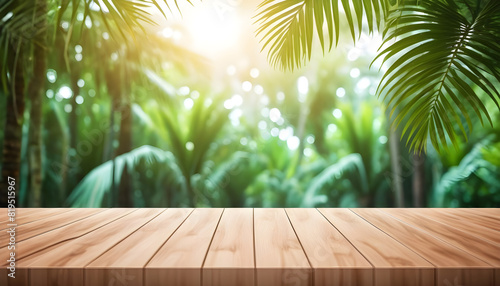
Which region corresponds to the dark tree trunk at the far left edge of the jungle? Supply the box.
[0,47,25,207]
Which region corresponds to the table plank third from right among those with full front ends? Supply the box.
[286,209,373,286]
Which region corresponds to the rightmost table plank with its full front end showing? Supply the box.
[352,209,495,286]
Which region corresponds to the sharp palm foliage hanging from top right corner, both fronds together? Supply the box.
[257,0,500,152]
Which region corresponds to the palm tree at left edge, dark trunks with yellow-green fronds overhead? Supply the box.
[0,0,195,206]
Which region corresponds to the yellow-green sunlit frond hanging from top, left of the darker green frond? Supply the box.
[256,0,390,70]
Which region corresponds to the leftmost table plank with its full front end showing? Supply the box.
[23,209,163,286]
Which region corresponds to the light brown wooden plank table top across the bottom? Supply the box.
[0,208,500,286]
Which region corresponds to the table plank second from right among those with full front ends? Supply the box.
[319,209,434,286]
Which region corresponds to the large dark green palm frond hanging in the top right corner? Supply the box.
[377,0,500,151]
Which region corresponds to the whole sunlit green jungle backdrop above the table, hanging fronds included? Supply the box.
[0,0,500,207]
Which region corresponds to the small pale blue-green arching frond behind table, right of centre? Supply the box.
[301,153,368,207]
